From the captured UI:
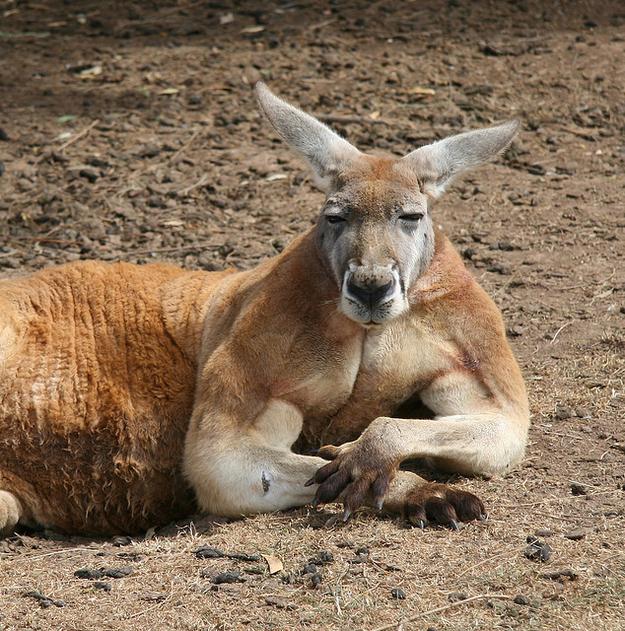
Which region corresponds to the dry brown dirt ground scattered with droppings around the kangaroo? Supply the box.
[0,0,625,631]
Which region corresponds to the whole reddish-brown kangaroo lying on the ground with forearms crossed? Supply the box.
[0,83,529,534]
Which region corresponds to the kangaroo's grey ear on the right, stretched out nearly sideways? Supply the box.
[400,120,520,198]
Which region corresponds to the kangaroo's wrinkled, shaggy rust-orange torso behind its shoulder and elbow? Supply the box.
[0,264,204,533]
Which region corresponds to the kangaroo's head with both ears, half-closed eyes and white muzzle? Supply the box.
[256,83,519,325]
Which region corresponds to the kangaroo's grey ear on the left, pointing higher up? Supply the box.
[255,81,361,192]
